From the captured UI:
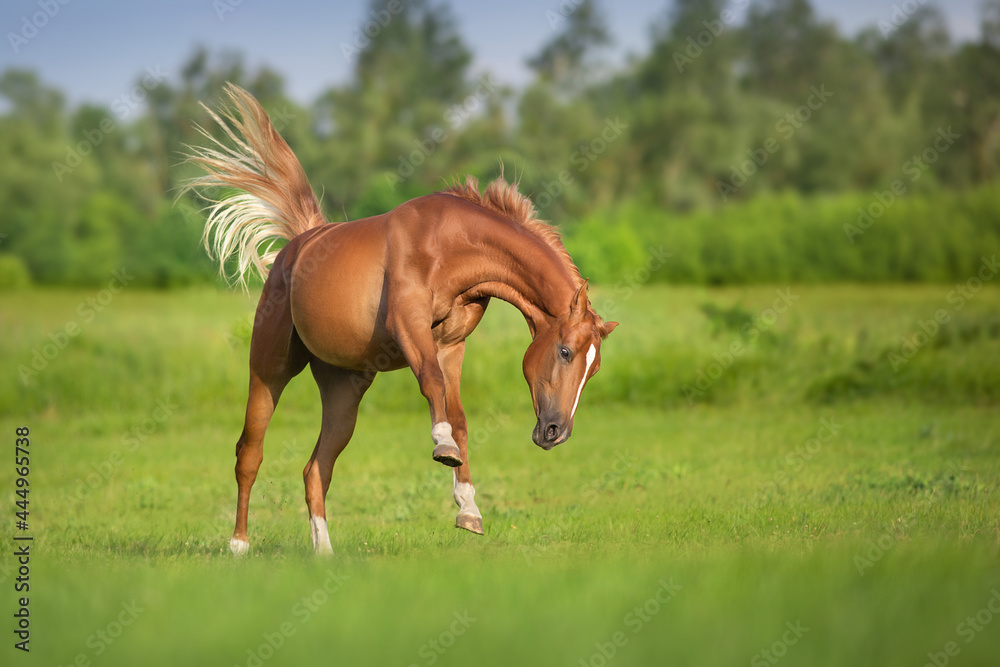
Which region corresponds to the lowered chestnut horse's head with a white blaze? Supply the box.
[524,283,618,449]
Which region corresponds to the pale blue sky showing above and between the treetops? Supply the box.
[0,0,979,105]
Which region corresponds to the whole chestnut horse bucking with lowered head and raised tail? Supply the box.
[182,84,618,556]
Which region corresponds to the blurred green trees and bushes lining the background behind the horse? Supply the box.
[0,0,1000,287]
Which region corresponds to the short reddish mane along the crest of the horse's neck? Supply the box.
[441,175,583,287]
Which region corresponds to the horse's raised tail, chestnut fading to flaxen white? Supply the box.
[182,83,326,286]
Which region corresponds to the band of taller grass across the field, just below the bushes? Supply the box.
[0,286,1000,416]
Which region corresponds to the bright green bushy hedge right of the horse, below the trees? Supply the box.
[566,186,1000,285]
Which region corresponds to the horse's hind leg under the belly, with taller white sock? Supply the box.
[302,358,375,554]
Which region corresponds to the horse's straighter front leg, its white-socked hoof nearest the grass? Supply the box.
[438,341,483,535]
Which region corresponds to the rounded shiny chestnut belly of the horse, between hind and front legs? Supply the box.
[291,224,404,371]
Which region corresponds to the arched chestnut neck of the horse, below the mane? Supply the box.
[456,218,576,335]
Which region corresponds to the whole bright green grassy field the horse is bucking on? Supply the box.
[0,284,1000,667]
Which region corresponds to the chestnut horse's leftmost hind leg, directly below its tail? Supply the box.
[229,272,310,556]
